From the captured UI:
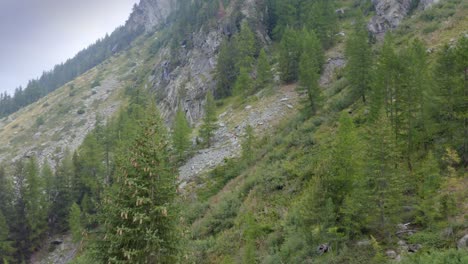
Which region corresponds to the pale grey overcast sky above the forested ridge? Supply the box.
[0,0,139,92]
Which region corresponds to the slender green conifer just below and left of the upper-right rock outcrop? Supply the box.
[345,14,372,103]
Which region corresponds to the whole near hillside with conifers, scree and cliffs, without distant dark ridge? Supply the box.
[0,0,468,263]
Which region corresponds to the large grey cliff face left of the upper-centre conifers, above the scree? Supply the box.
[148,0,266,124]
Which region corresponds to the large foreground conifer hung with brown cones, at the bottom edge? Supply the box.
[101,103,179,264]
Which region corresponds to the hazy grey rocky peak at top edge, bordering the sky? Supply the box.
[125,0,176,32]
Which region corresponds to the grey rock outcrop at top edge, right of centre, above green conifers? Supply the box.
[368,0,411,35]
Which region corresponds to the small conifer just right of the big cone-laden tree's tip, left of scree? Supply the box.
[172,106,191,160]
